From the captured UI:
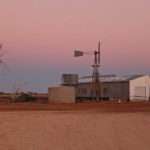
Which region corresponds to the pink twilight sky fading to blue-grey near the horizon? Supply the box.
[0,0,150,91]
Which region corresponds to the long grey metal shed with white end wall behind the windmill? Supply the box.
[76,75,150,101]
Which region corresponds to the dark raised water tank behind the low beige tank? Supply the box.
[62,74,79,86]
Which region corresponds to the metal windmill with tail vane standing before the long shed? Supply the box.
[74,41,101,101]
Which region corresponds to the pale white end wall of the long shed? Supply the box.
[129,75,150,101]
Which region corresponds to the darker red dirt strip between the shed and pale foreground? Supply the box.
[0,102,150,112]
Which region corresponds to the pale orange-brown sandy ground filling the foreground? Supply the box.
[0,111,150,150]
